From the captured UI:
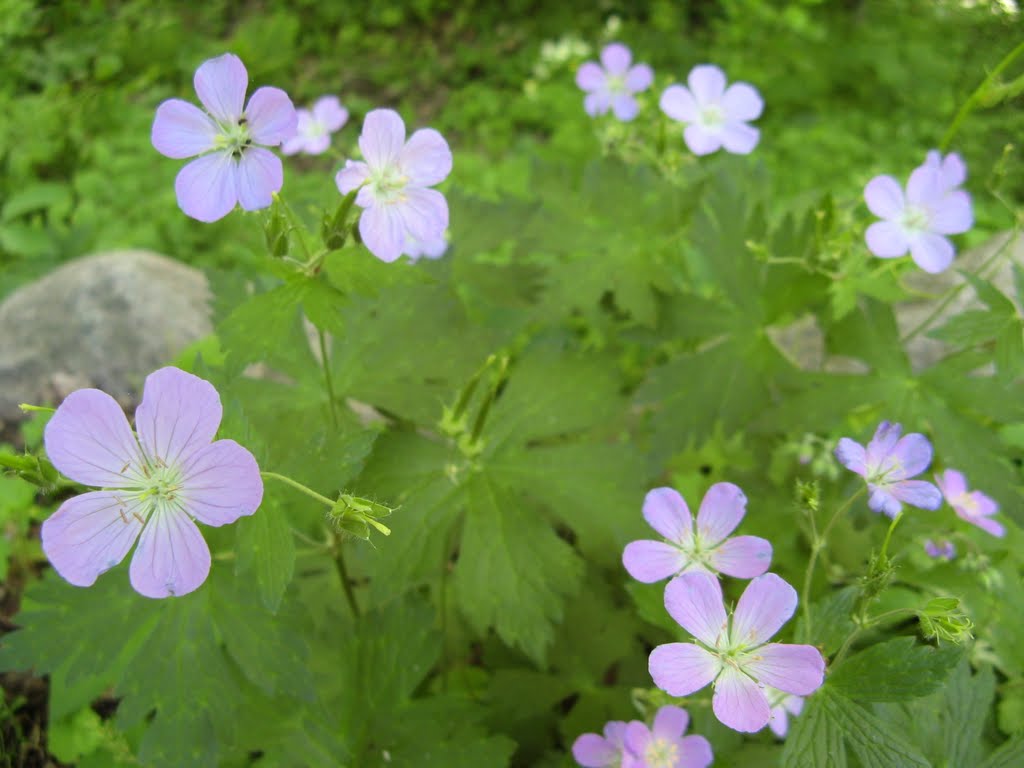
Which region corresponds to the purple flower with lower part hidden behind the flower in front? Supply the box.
[623,482,771,584]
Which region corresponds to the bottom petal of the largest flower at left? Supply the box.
[129,509,210,598]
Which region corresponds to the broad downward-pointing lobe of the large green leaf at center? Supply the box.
[455,474,583,665]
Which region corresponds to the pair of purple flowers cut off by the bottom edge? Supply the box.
[572,706,714,768]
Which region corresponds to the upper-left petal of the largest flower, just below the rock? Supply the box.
[43,389,142,488]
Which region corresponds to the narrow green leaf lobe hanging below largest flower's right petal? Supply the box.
[234,497,295,612]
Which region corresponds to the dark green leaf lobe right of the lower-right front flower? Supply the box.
[828,637,964,701]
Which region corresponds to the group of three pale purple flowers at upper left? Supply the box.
[152,53,452,261]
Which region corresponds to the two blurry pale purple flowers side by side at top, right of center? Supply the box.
[577,43,764,155]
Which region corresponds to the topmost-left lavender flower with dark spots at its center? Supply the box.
[152,53,297,221]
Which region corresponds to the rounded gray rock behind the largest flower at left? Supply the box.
[0,251,212,422]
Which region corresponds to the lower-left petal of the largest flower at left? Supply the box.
[40,490,142,587]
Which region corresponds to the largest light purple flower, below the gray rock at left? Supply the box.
[41,368,263,597]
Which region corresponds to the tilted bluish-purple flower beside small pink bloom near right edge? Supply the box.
[836,421,942,517]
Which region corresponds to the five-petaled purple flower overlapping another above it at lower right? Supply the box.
[648,572,825,732]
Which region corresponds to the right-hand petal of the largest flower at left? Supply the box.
[181,440,263,525]
